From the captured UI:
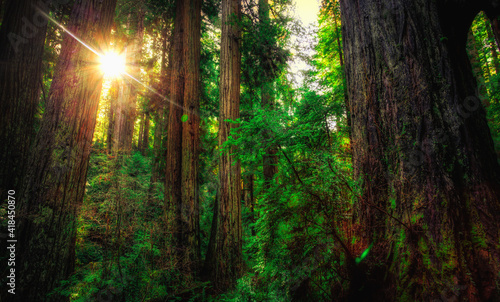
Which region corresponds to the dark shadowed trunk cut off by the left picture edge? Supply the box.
[0,0,47,199]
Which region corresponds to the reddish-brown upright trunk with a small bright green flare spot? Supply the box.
[165,0,201,276]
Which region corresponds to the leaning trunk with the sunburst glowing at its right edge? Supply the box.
[16,0,116,301]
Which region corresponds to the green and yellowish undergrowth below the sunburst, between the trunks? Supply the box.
[53,152,186,301]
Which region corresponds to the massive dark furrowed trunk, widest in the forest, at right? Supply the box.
[341,0,500,301]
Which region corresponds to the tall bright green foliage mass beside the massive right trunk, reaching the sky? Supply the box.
[214,0,356,301]
